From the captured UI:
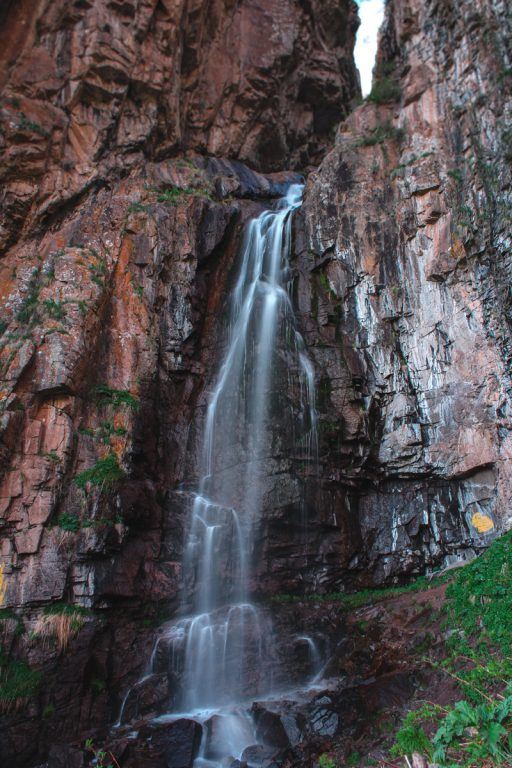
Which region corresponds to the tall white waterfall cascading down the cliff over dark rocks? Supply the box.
[118,184,328,768]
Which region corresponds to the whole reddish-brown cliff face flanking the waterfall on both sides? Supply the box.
[0,0,512,768]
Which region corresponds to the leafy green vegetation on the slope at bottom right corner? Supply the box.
[391,532,512,768]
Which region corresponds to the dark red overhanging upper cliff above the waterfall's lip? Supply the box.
[0,0,358,252]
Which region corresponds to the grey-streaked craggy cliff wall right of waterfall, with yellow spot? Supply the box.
[297,0,512,580]
